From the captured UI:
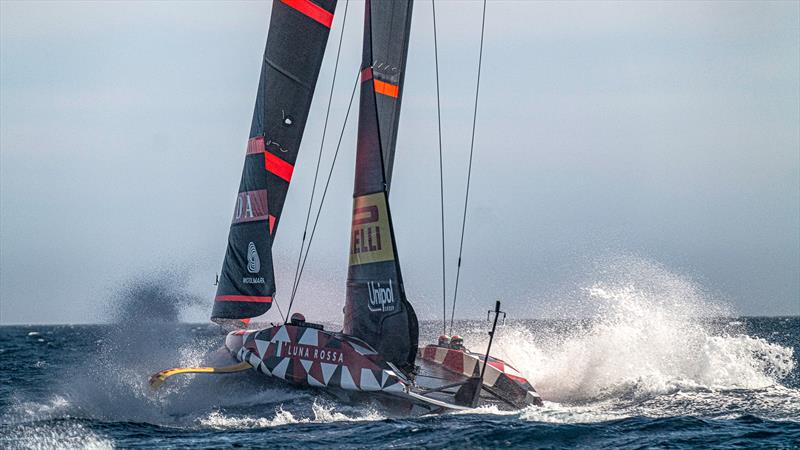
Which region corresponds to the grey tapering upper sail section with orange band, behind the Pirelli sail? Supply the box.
[370,0,414,190]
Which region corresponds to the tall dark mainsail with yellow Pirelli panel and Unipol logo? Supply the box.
[344,0,419,372]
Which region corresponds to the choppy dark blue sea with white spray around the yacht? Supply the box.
[0,285,800,449]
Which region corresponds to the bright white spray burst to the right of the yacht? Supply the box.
[484,258,800,420]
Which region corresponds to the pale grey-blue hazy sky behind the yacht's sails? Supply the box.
[0,0,800,324]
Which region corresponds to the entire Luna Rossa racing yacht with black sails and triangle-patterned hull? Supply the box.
[151,0,541,412]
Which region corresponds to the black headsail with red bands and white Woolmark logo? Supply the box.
[211,0,336,323]
